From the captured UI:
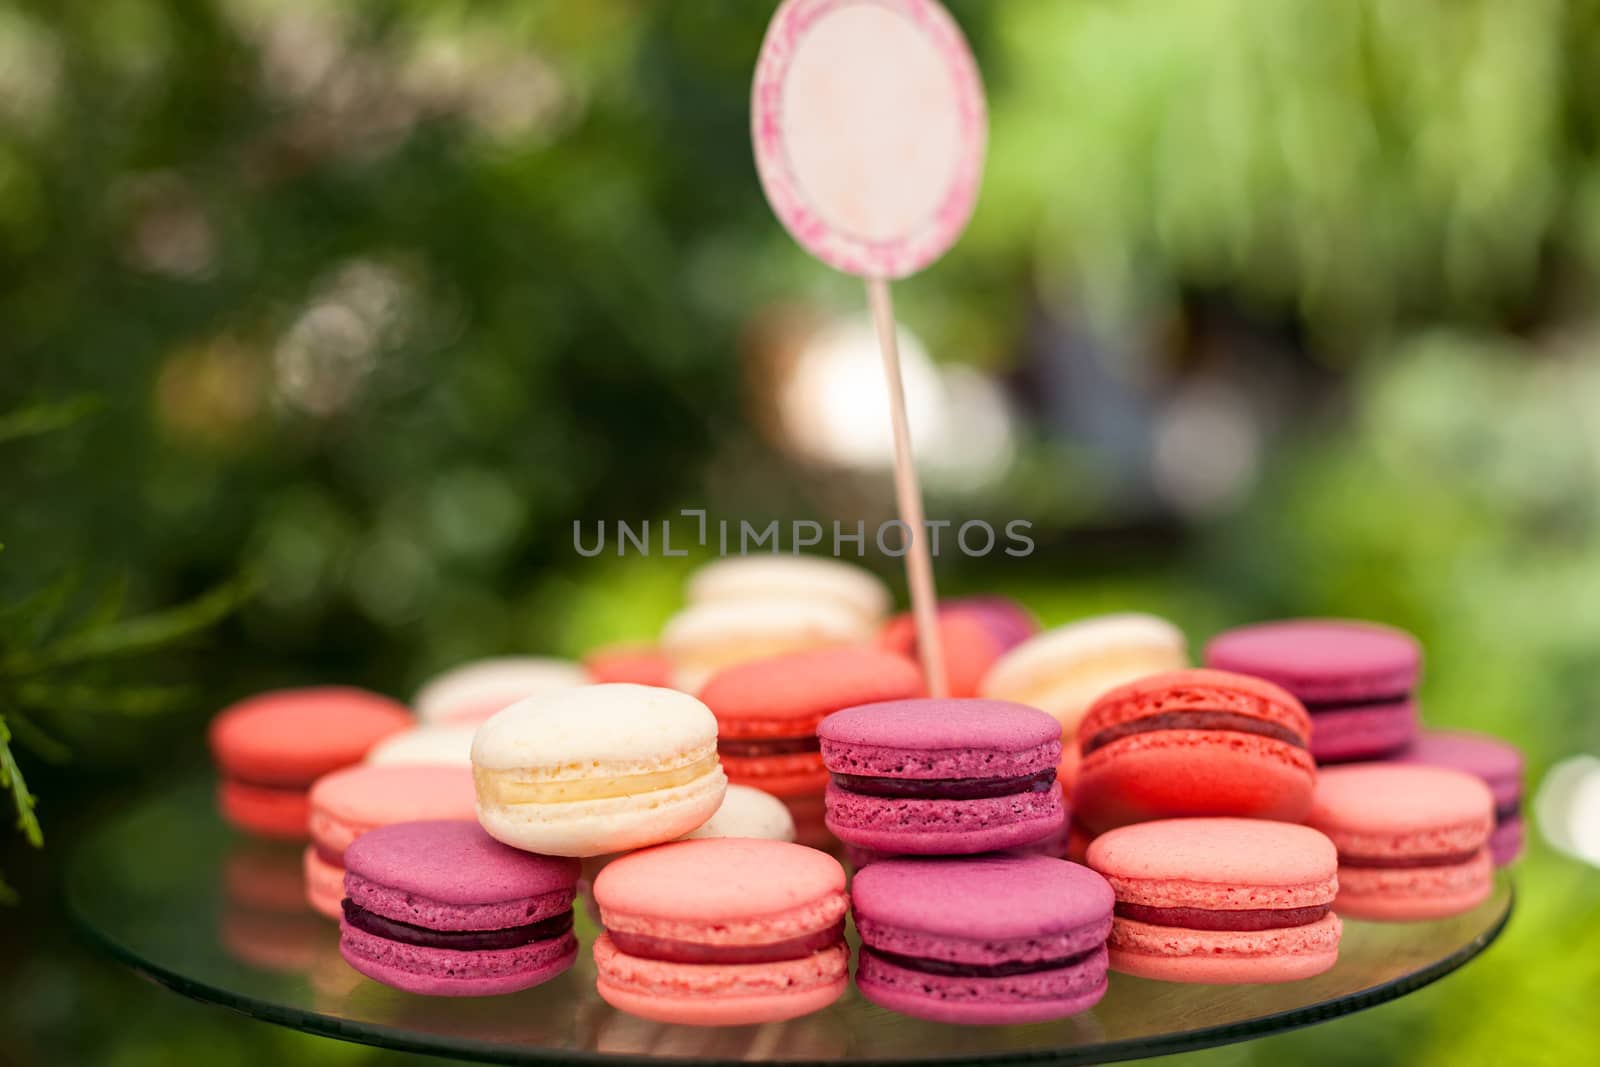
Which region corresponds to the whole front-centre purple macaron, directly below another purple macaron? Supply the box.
[851,856,1112,1025]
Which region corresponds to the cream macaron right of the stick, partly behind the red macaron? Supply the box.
[978,613,1189,742]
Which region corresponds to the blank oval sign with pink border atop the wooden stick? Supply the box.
[750,0,989,278]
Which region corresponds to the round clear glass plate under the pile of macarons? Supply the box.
[67,782,1512,1067]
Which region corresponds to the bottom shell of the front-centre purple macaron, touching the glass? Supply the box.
[856,947,1106,1025]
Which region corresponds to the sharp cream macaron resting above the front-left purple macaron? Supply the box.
[472,683,728,856]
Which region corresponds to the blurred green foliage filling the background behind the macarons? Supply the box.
[0,0,1600,1064]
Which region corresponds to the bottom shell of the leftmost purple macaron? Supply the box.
[339,923,578,997]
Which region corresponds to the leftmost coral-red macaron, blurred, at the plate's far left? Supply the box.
[208,686,414,841]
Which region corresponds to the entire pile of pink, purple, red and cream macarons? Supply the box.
[211,588,1522,1025]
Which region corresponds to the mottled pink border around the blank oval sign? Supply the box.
[750,0,989,278]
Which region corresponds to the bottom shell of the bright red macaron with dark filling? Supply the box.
[1072,729,1317,833]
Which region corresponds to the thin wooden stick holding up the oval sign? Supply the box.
[867,278,949,696]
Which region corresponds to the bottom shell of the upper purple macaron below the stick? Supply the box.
[826,782,1067,856]
